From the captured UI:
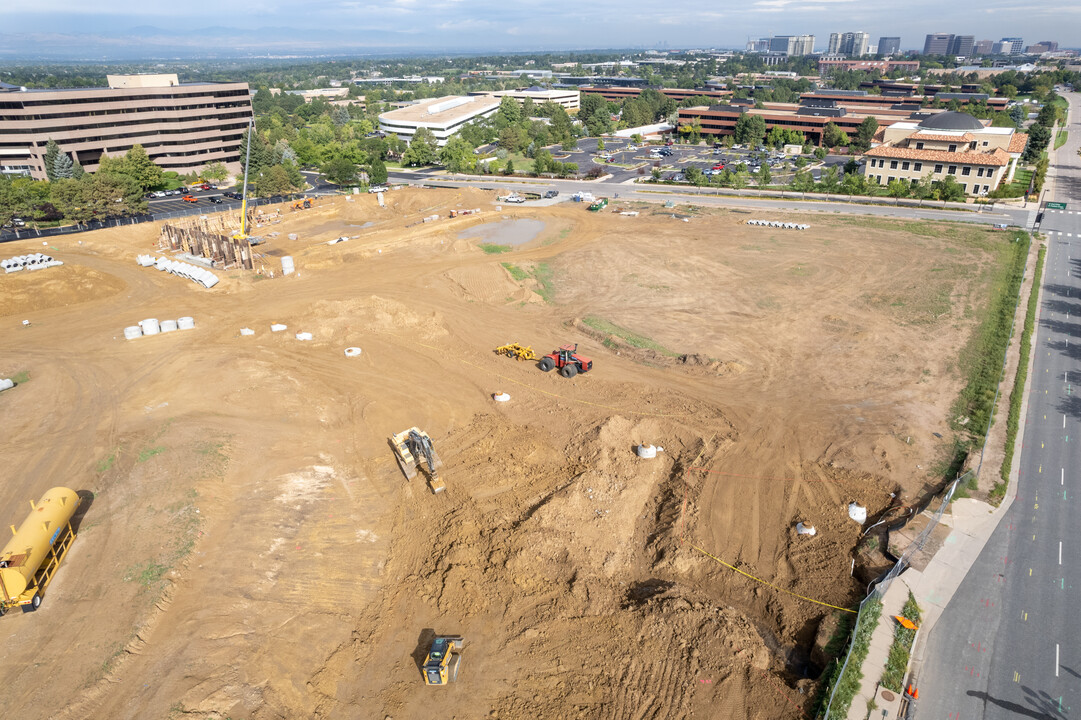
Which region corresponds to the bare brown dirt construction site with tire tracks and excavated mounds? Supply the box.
[0,188,1005,720]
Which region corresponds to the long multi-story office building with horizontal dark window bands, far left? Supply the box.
[0,75,252,179]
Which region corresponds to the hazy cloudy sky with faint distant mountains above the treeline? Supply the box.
[0,0,1081,54]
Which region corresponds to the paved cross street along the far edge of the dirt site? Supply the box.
[390,172,1036,228]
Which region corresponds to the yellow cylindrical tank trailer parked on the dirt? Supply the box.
[0,488,80,615]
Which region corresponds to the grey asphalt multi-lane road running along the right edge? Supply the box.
[917,95,1081,720]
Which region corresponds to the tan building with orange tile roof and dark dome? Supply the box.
[864,112,1028,196]
